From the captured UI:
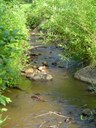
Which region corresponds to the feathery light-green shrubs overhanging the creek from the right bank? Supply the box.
[27,0,96,63]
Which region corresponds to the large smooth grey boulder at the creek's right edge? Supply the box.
[74,65,96,84]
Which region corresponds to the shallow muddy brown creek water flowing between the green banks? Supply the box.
[3,33,96,128]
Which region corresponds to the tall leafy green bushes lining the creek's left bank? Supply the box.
[0,0,28,89]
